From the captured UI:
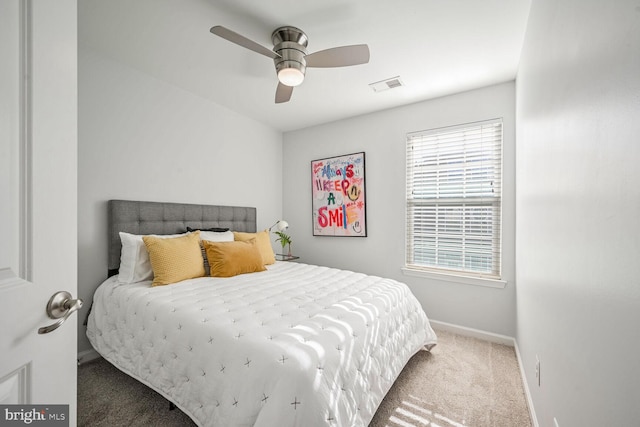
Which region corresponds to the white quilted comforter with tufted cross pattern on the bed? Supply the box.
[87,262,436,427]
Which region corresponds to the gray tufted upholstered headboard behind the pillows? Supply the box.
[108,200,256,276]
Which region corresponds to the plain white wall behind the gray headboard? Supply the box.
[78,46,282,351]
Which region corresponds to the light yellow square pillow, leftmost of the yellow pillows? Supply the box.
[142,232,204,286]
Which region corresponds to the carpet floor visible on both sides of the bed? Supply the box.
[78,331,531,427]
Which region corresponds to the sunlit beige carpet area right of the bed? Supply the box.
[370,331,531,427]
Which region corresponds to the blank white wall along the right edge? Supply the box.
[516,0,640,427]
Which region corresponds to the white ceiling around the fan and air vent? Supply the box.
[78,0,531,131]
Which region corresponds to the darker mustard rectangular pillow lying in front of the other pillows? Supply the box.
[202,239,266,277]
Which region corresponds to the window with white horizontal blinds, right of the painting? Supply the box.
[406,119,502,279]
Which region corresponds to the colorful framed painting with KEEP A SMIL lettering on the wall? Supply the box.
[311,153,367,237]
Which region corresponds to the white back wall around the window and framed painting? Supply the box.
[283,82,516,336]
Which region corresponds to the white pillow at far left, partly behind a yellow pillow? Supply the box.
[118,231,186,284]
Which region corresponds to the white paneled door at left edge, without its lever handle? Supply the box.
[0,0,78,426]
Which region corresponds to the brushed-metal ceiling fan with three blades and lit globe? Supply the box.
[210,25,369,104]
